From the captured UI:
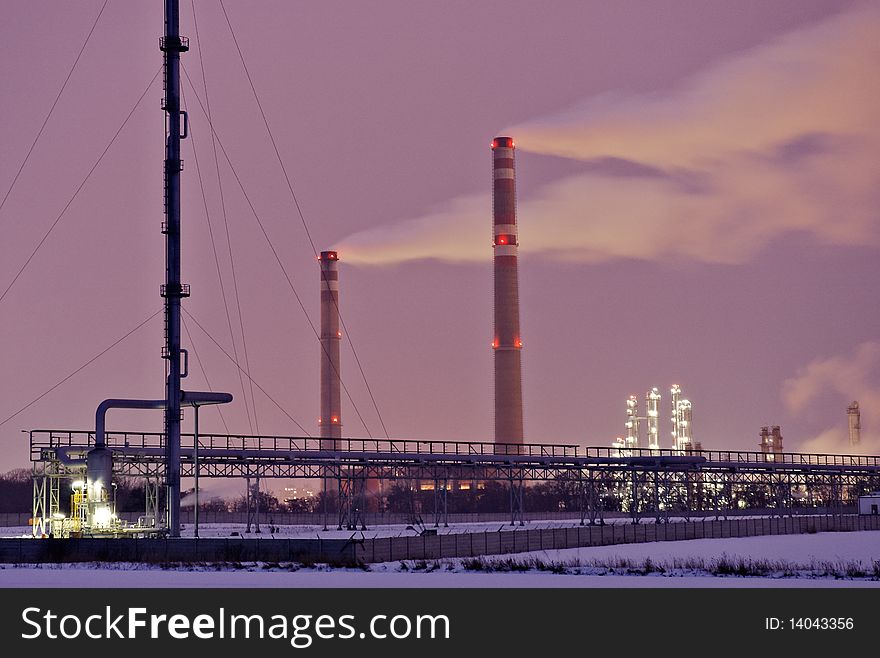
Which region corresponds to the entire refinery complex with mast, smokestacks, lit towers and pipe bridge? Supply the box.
[1,0,880,554]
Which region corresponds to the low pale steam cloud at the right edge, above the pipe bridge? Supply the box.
[782,341,880,455]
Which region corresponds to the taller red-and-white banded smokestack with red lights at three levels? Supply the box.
[492,137,523,444]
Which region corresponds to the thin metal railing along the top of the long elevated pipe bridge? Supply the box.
[29,430,880,467]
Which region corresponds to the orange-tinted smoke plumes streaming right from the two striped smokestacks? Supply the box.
[339,7,880,264]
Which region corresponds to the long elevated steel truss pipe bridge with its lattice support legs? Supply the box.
[25,431,880,534]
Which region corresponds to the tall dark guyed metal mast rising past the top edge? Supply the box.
[159,0,189,537]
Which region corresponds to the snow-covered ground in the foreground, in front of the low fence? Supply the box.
[0,525,880,588]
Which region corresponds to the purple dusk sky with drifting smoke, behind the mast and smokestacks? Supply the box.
[0,0,880,471]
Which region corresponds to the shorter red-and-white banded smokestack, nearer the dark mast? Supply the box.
[318,251,342,450]
